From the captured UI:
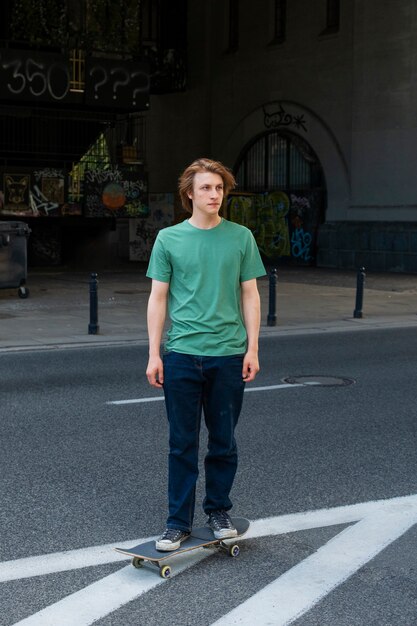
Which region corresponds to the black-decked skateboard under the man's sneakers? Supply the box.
[115,517,250,578]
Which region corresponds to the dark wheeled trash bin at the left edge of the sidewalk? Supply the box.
[0,221,31,298]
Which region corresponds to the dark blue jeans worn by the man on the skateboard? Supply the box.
[163,352,245,531]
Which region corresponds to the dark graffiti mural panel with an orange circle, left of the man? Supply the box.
[84,168,149,218]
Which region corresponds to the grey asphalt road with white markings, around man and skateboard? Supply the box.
[0,329,417,626]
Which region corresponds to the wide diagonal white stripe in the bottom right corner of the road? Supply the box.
[213,500,417,626]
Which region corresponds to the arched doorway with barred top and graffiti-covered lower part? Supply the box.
[228,130,326,265]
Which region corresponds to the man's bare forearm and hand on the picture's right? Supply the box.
[241,278,261,383]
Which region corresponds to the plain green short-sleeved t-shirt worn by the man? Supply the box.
[146,219,266,356]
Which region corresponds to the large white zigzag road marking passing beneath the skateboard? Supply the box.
[4,495,417,626]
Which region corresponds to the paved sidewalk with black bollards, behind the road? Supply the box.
[0,263,417,351]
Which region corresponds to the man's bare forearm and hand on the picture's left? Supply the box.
[146,280,169,388]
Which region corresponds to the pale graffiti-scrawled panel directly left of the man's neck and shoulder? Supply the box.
[129,193,175,261]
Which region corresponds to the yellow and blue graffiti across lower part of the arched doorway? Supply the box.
[228,191,320,263]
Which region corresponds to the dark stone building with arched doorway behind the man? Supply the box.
[146,0,417,272]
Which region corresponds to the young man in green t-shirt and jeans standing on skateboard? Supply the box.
[146,159,265,551]
